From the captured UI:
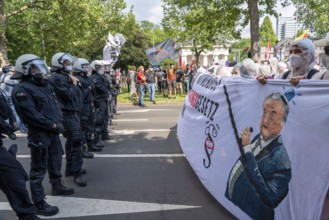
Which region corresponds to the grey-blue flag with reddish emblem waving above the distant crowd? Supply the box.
[145,38,175,66]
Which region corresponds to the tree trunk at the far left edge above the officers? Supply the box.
[0,0,9,67]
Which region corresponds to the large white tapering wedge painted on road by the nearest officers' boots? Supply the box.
[0,196,201,219]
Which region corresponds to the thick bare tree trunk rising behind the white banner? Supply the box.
[248,0,260,63]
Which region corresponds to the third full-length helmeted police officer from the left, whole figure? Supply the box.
[73,58,102,155]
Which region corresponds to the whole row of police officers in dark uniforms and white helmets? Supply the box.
[0,52,120,220]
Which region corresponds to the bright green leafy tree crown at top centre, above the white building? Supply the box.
[162,0,241,63]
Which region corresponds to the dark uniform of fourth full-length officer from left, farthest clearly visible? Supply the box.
[90,71,109,145]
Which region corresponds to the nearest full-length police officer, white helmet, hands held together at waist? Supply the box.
[11,54,74,216]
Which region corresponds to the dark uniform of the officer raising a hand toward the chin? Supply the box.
[49,70,86,186]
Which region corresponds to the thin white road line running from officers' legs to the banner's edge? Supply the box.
[16,153,185,159]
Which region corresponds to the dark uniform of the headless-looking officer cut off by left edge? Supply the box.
[0,93,40,220]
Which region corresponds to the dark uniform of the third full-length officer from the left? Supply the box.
[76,72,102,151]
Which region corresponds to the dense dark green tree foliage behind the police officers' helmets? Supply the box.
[7,0,126,63]
